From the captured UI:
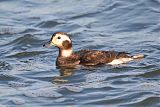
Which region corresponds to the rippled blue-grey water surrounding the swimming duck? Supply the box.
[0,0,160,107]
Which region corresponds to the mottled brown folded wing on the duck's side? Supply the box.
[75,50,130,65]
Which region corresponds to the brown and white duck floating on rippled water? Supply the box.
[43,32,144,67]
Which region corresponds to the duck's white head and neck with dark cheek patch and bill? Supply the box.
[43,32,72,57]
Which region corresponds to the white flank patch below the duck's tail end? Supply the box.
[108,58,133,65]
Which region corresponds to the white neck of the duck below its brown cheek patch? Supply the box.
[59,48,73,57]
